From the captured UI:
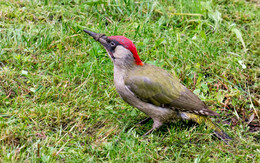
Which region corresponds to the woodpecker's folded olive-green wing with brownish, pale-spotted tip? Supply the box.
[125,64,218,115]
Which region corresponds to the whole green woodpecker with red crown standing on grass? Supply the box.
[84,30,231,142]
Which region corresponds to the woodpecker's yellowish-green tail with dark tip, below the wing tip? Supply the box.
[181,113,232,143]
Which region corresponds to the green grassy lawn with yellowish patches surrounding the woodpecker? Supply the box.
[0,0,260,162]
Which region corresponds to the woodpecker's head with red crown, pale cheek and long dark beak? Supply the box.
[84,30,144,66]
